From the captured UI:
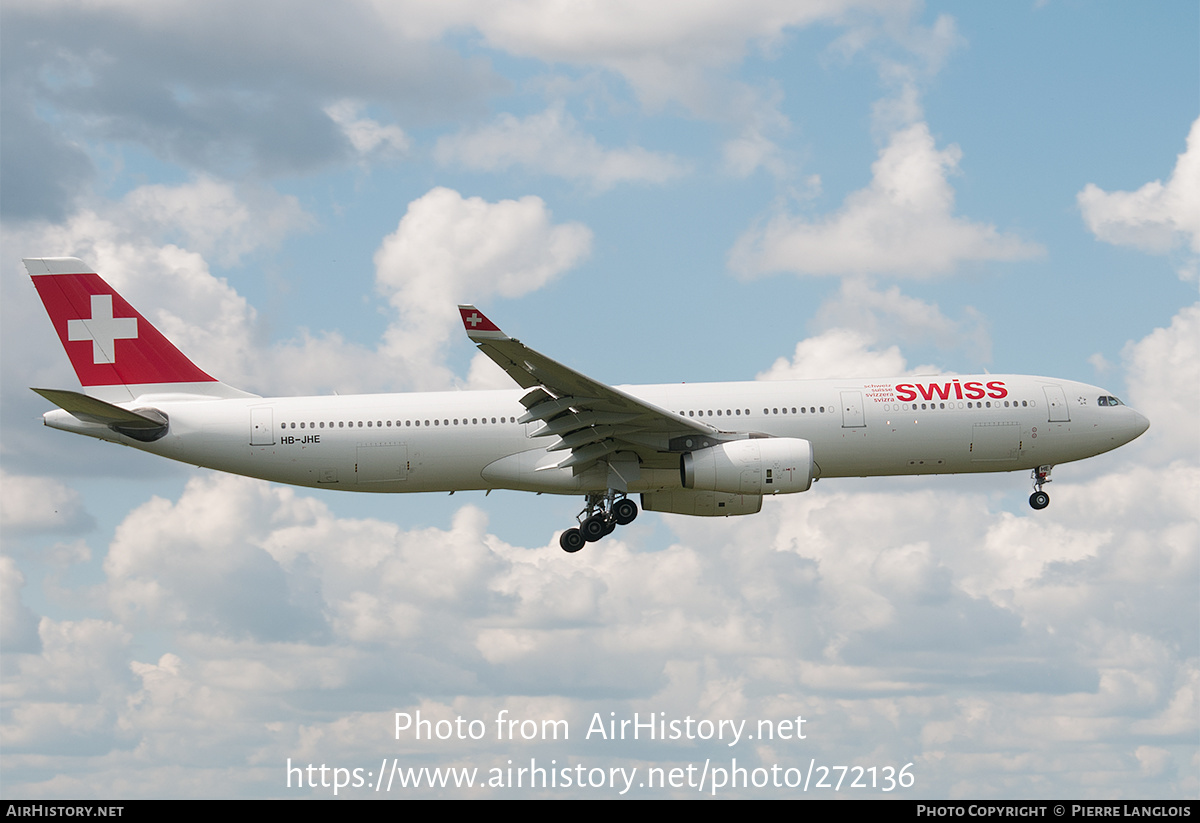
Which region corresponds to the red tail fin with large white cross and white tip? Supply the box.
[24,257,244,397]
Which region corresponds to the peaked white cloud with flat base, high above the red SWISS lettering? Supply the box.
[730,124,1042,277]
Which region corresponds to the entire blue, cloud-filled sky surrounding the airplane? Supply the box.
[0,0,1200,798]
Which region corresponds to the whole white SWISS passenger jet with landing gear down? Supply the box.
[24,257,1150,552]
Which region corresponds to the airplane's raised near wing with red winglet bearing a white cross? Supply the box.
[458,306,729,479]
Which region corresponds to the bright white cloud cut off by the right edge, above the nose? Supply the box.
[1075,119,1200,278]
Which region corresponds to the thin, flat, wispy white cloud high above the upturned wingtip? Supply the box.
[434,106,685,191]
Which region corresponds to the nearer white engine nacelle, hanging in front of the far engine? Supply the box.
[679,437,812,494]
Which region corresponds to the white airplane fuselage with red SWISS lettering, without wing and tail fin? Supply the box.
[44,374,1148,493]
